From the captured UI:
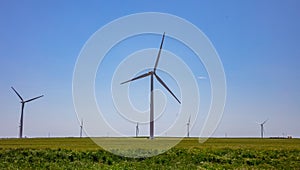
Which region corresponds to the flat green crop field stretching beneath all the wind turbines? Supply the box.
[0,138,300,169]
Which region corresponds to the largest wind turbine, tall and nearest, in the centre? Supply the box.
[121,33,181,139]
